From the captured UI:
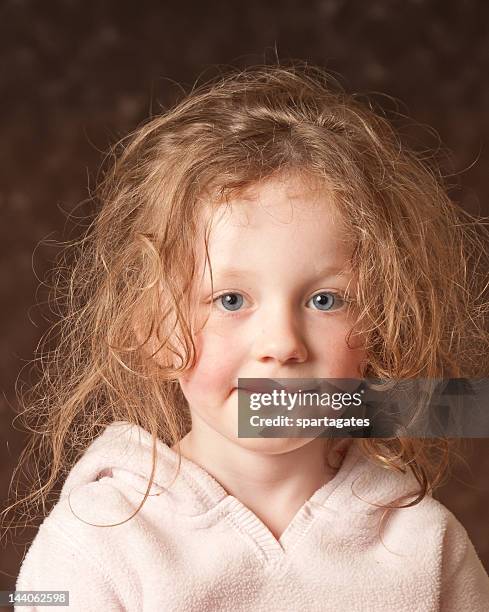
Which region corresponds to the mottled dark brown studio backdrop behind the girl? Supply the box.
[0,0,489,590]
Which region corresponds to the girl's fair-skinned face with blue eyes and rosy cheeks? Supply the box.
[179,175,365,452]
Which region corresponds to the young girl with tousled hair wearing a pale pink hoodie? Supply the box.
[3,65,489,612]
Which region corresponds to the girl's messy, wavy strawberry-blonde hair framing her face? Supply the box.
[1,63,488,540]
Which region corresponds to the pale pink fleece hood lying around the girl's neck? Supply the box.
[61,421,419,522]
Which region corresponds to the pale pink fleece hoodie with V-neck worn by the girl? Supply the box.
[16,422,489,612]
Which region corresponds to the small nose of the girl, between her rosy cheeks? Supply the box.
[252,306,308,364]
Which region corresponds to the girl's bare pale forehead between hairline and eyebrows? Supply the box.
[196,174,351,265]
